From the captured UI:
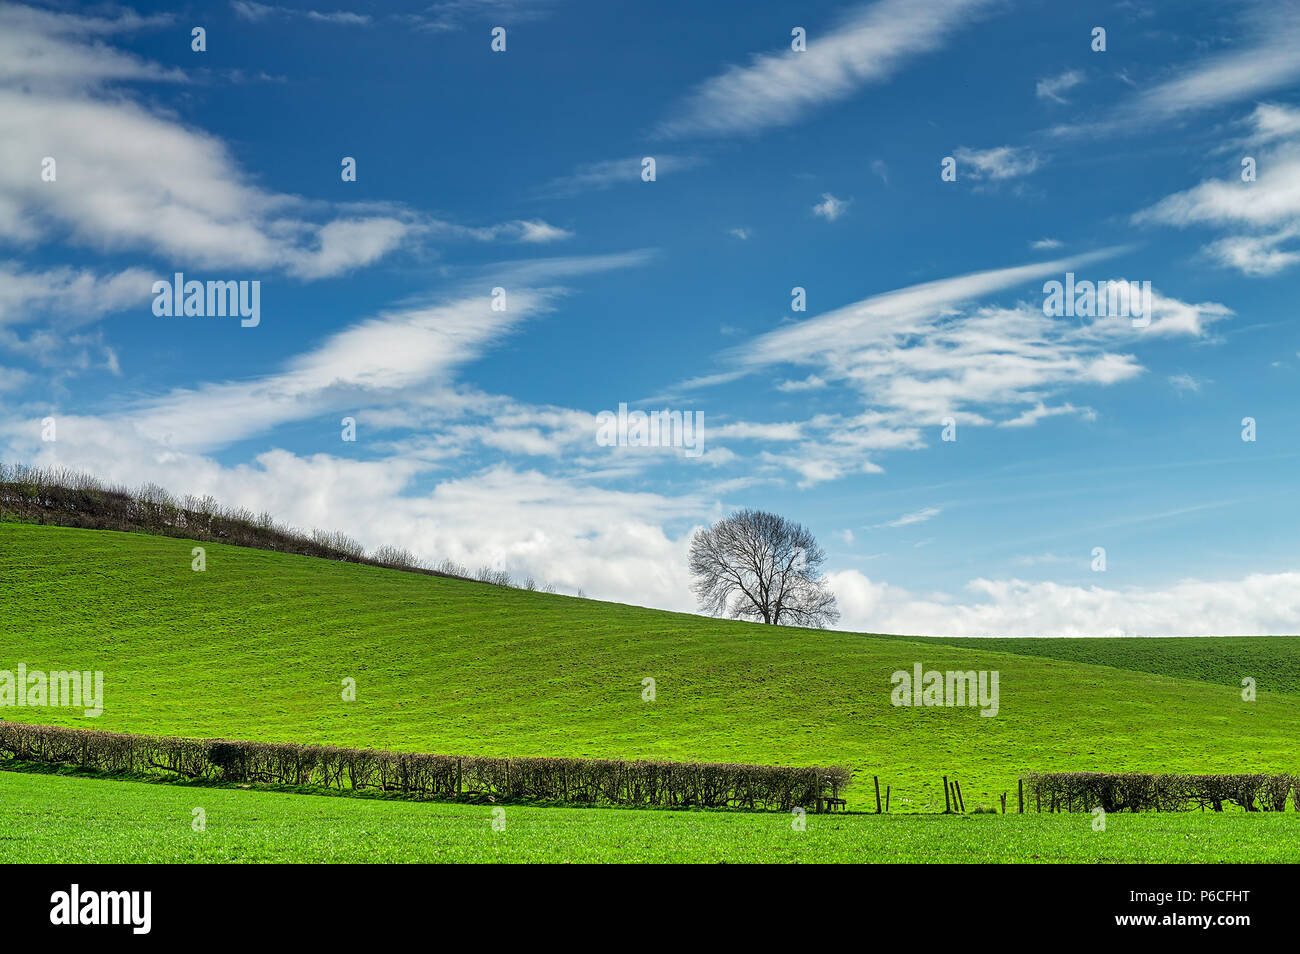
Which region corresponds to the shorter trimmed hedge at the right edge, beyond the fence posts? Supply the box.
[1026,772,1300,812]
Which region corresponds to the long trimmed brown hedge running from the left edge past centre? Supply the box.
[0,721,849,811]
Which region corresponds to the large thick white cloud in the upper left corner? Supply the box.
[0,6,419,278]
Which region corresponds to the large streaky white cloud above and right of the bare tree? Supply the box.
[703,250,1232,486]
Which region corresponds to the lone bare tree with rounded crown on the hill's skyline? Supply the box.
[690,509,840,629]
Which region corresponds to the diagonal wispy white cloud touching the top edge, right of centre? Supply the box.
[659,0,988,136]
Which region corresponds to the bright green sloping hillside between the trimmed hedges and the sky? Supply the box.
[0,524,1300,811]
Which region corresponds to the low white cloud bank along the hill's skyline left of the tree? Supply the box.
[0,415,710,611]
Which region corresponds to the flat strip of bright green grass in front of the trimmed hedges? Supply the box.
[0,771,1300,863]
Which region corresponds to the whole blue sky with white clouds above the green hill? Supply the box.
[0,0,1300,636]
